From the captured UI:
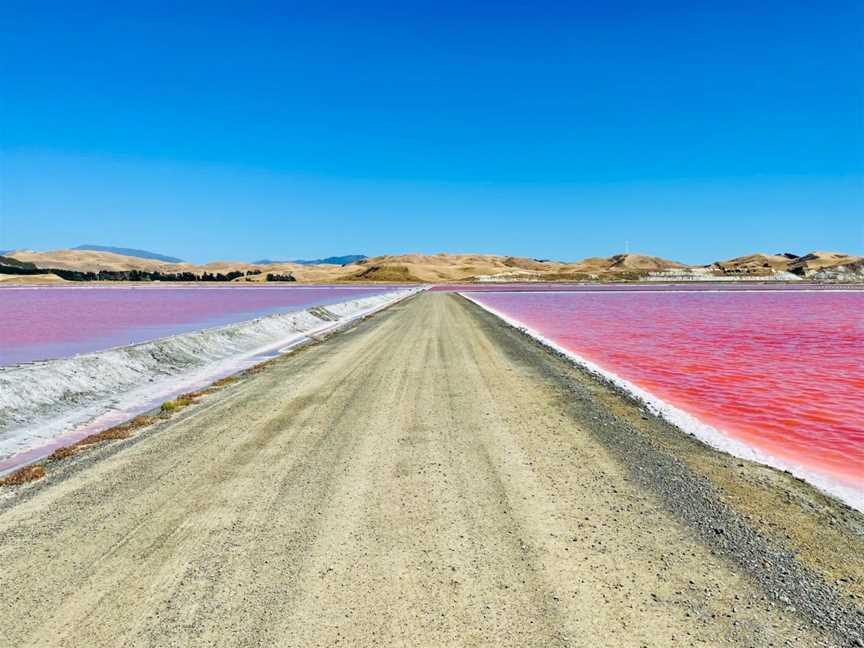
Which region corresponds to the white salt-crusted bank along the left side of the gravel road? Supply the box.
[0,288,418,476]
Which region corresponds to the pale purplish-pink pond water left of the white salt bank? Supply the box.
[0,286,392,365]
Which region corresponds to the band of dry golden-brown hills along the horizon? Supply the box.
[0,246,864,283]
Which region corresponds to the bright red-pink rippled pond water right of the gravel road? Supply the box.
[471,288,864,489]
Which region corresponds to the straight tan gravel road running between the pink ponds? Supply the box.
[0,293,864,647]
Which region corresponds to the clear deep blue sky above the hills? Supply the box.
[0,0,864,262]
